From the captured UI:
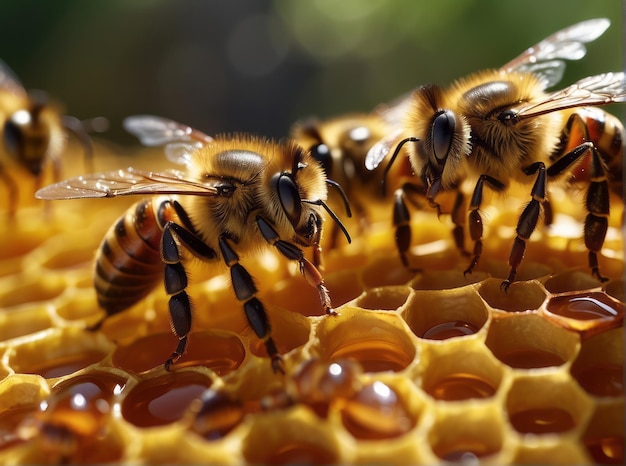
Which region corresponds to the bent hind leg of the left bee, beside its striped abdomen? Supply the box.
[161,221,217,371]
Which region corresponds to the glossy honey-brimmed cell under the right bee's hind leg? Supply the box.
[544,291,624,339]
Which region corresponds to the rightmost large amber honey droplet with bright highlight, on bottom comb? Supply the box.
[341,381,415,440]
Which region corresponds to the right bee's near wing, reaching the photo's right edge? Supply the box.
[513,72,626,119]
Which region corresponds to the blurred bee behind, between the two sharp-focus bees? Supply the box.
[291,105,412,248]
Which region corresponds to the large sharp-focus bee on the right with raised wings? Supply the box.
[366,19,626,291]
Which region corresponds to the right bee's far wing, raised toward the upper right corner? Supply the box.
[501,18,611,89]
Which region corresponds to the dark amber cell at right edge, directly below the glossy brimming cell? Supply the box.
[570,328,624,397]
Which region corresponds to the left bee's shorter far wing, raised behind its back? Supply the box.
[123,115,213,146]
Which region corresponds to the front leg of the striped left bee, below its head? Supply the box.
[256,217,337,315]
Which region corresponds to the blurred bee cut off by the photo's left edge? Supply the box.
[0,61,100,216]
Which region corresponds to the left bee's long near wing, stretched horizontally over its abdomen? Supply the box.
[35,168,217,200]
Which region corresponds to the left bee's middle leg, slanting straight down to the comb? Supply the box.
[219,235,285,374]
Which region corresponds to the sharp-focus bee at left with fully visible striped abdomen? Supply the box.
[36,115,350,372]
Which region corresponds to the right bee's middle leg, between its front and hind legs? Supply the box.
[500,162,551,291]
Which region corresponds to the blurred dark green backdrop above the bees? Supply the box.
[0,0,623,143]
